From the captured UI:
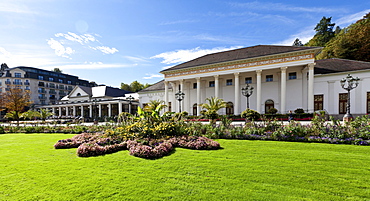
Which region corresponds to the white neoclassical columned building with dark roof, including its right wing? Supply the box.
[139,45,370,118]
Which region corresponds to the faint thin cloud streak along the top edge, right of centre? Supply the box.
[231,1,345,13]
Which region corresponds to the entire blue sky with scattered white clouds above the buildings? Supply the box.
[0,0,370,87]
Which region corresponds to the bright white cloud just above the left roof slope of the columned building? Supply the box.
[151,46,241,64]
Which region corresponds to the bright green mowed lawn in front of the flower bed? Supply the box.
[0,134,370,200]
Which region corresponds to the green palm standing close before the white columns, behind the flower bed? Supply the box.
[200,97,226,124]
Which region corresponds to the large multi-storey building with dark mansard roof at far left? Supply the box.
[0,66,95,106]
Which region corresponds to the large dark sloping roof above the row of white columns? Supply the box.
[161,45,321,72]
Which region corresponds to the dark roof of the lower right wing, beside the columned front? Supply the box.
[315,58,370,74]
